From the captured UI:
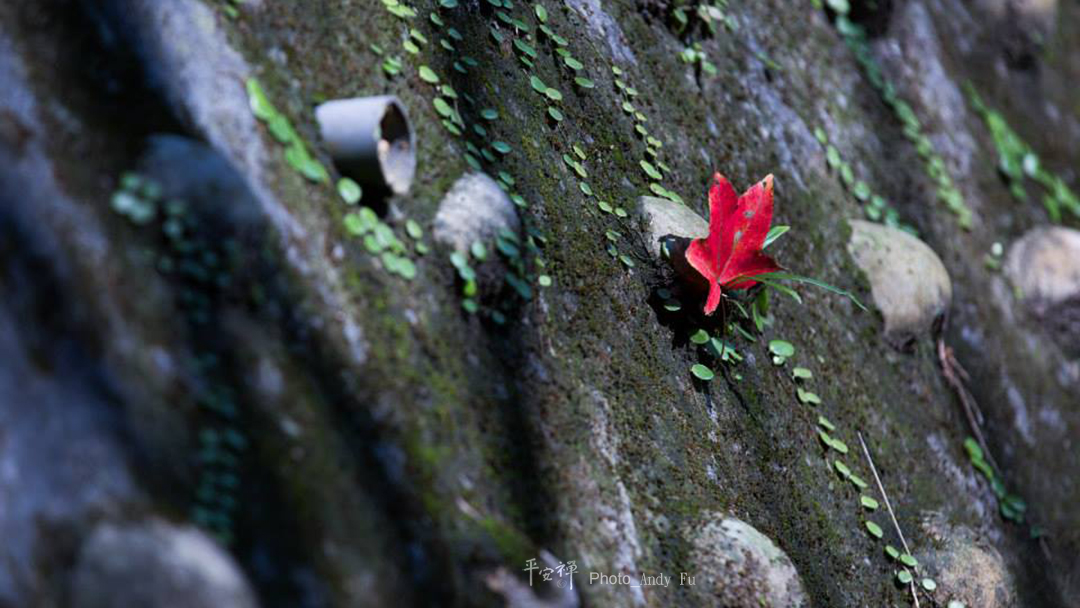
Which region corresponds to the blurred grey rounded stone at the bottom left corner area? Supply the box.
[71,521,258,608]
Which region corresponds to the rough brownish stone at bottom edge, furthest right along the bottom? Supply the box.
[915,514,1017,608]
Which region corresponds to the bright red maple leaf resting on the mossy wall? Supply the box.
[686,173,781,314]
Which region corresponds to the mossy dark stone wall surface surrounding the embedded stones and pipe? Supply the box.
[0,0,1080,607]
